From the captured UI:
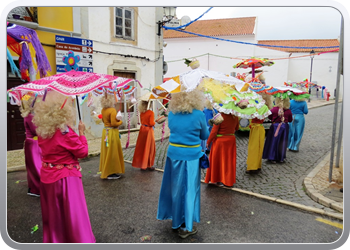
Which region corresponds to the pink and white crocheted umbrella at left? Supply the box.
[7,70,140,119]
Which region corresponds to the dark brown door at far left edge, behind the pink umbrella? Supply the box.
[7,78,26,151]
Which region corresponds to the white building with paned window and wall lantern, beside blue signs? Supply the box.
[79,7,163,137]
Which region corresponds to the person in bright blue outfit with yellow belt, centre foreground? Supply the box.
[157,89,209,238]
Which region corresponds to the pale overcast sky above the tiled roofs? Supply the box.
[176,7,342,40]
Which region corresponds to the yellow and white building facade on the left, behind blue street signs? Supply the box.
[7,7,163,148]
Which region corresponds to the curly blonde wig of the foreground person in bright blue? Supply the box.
[168,88,205,114]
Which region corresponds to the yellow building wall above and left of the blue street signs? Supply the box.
[36,7,73,76]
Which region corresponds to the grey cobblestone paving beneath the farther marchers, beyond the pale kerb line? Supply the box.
[124,105,339,213]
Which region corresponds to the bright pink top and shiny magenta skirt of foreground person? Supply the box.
[39,128,96,243]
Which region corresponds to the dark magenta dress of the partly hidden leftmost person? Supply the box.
[24,114,41,195]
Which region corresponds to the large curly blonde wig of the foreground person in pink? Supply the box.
[33,91,76,139]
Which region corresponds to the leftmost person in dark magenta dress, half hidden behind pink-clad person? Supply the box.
[20,94,41,197]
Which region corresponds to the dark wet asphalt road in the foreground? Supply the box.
[6,156,344,245]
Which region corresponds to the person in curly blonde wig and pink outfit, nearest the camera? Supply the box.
[33,91,96,243]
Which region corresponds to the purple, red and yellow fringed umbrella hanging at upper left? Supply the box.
[7,22,51,81]
